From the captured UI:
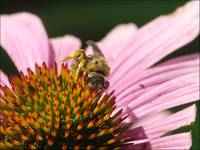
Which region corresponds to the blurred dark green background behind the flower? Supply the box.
[0,0,200,149]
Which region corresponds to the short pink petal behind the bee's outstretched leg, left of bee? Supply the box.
[50,35,81,63]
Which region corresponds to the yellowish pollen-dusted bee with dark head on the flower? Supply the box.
[62,41,110,91]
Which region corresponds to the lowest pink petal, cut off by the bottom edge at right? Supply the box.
[151,132,192,150]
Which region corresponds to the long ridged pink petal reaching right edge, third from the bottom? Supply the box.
[128,74,199,119]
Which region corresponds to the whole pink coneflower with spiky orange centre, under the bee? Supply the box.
[0,1,199,150]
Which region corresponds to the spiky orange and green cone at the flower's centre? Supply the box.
[0,64,128,150]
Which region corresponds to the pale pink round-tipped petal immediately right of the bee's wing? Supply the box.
[87,23,137,64]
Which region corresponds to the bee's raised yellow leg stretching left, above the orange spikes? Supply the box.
[57,49,86,62]
